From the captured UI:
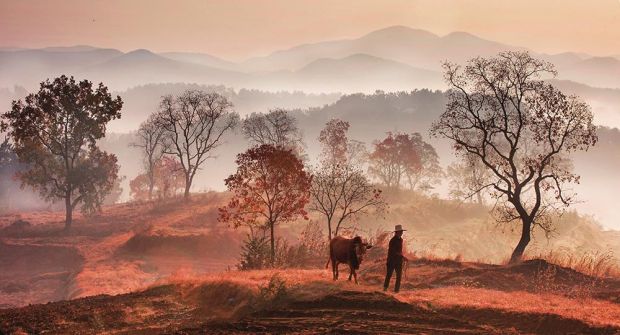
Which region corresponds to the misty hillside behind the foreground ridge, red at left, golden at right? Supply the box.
[0,192,620,307]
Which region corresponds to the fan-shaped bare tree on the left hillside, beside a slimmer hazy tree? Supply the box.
[155,90,239,199]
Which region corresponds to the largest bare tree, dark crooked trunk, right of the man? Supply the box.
[432,52,597,262]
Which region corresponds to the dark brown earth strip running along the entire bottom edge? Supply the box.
[0,286,620,335]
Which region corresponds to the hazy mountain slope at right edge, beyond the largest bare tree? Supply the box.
[559,57,620,88]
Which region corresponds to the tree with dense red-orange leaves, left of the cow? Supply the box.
[220,144,312,264]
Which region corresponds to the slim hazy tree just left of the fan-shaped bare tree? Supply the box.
[131,114,166,200]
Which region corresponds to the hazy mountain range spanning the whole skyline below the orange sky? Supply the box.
[0,26,620,93]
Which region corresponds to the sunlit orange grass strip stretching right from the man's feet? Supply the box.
[396,287,620,327]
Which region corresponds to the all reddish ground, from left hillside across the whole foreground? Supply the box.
[0,193,620,334]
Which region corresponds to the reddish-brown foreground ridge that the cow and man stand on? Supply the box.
[0,260,620,334]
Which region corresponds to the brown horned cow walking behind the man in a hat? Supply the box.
[325,236,372,284]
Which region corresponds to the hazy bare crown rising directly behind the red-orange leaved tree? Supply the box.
[241,109,302,149]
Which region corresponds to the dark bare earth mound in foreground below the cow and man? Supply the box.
[178,291,620,334]
